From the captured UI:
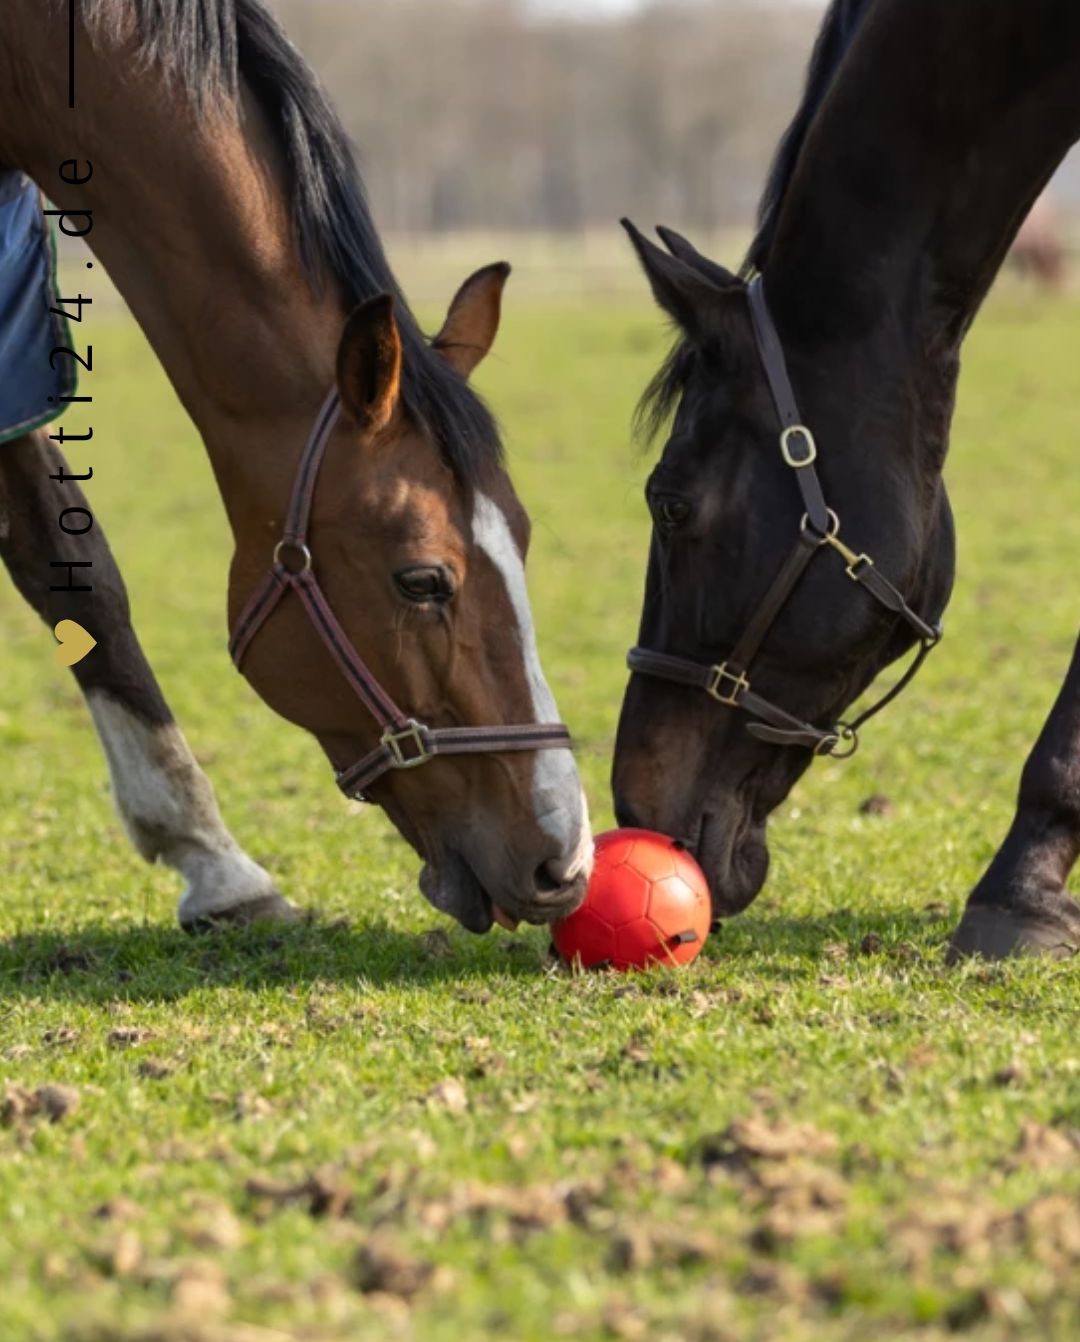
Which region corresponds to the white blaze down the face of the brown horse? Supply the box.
[472,493,592,880]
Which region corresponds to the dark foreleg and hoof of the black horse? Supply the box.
[949,643,1080,961]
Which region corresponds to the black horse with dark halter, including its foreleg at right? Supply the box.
[613,0,1080,960]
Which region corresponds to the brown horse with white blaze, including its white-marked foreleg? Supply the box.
[0,0,592,933]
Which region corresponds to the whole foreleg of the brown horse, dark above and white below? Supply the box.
[0,431,295,929]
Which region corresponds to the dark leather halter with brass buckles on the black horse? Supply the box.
[627,275,942,758]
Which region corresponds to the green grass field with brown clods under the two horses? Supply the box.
[0,275,1080,1342]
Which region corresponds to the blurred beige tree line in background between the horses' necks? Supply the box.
[271,0,820,232]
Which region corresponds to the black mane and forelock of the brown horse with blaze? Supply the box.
[82,0,500,482]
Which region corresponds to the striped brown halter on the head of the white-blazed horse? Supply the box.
[229,391,573,801]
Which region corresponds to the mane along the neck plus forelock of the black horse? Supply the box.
[635,0,876,442]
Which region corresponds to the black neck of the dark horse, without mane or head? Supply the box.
[765,0,1080,358]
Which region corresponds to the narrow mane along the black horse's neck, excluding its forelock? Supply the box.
[742,0,876,276]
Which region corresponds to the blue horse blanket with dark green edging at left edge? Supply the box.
[0,169,75,443]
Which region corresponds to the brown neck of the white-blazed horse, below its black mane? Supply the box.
[0,13,343,531]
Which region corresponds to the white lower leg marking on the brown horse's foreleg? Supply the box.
[86,690,274,923]
